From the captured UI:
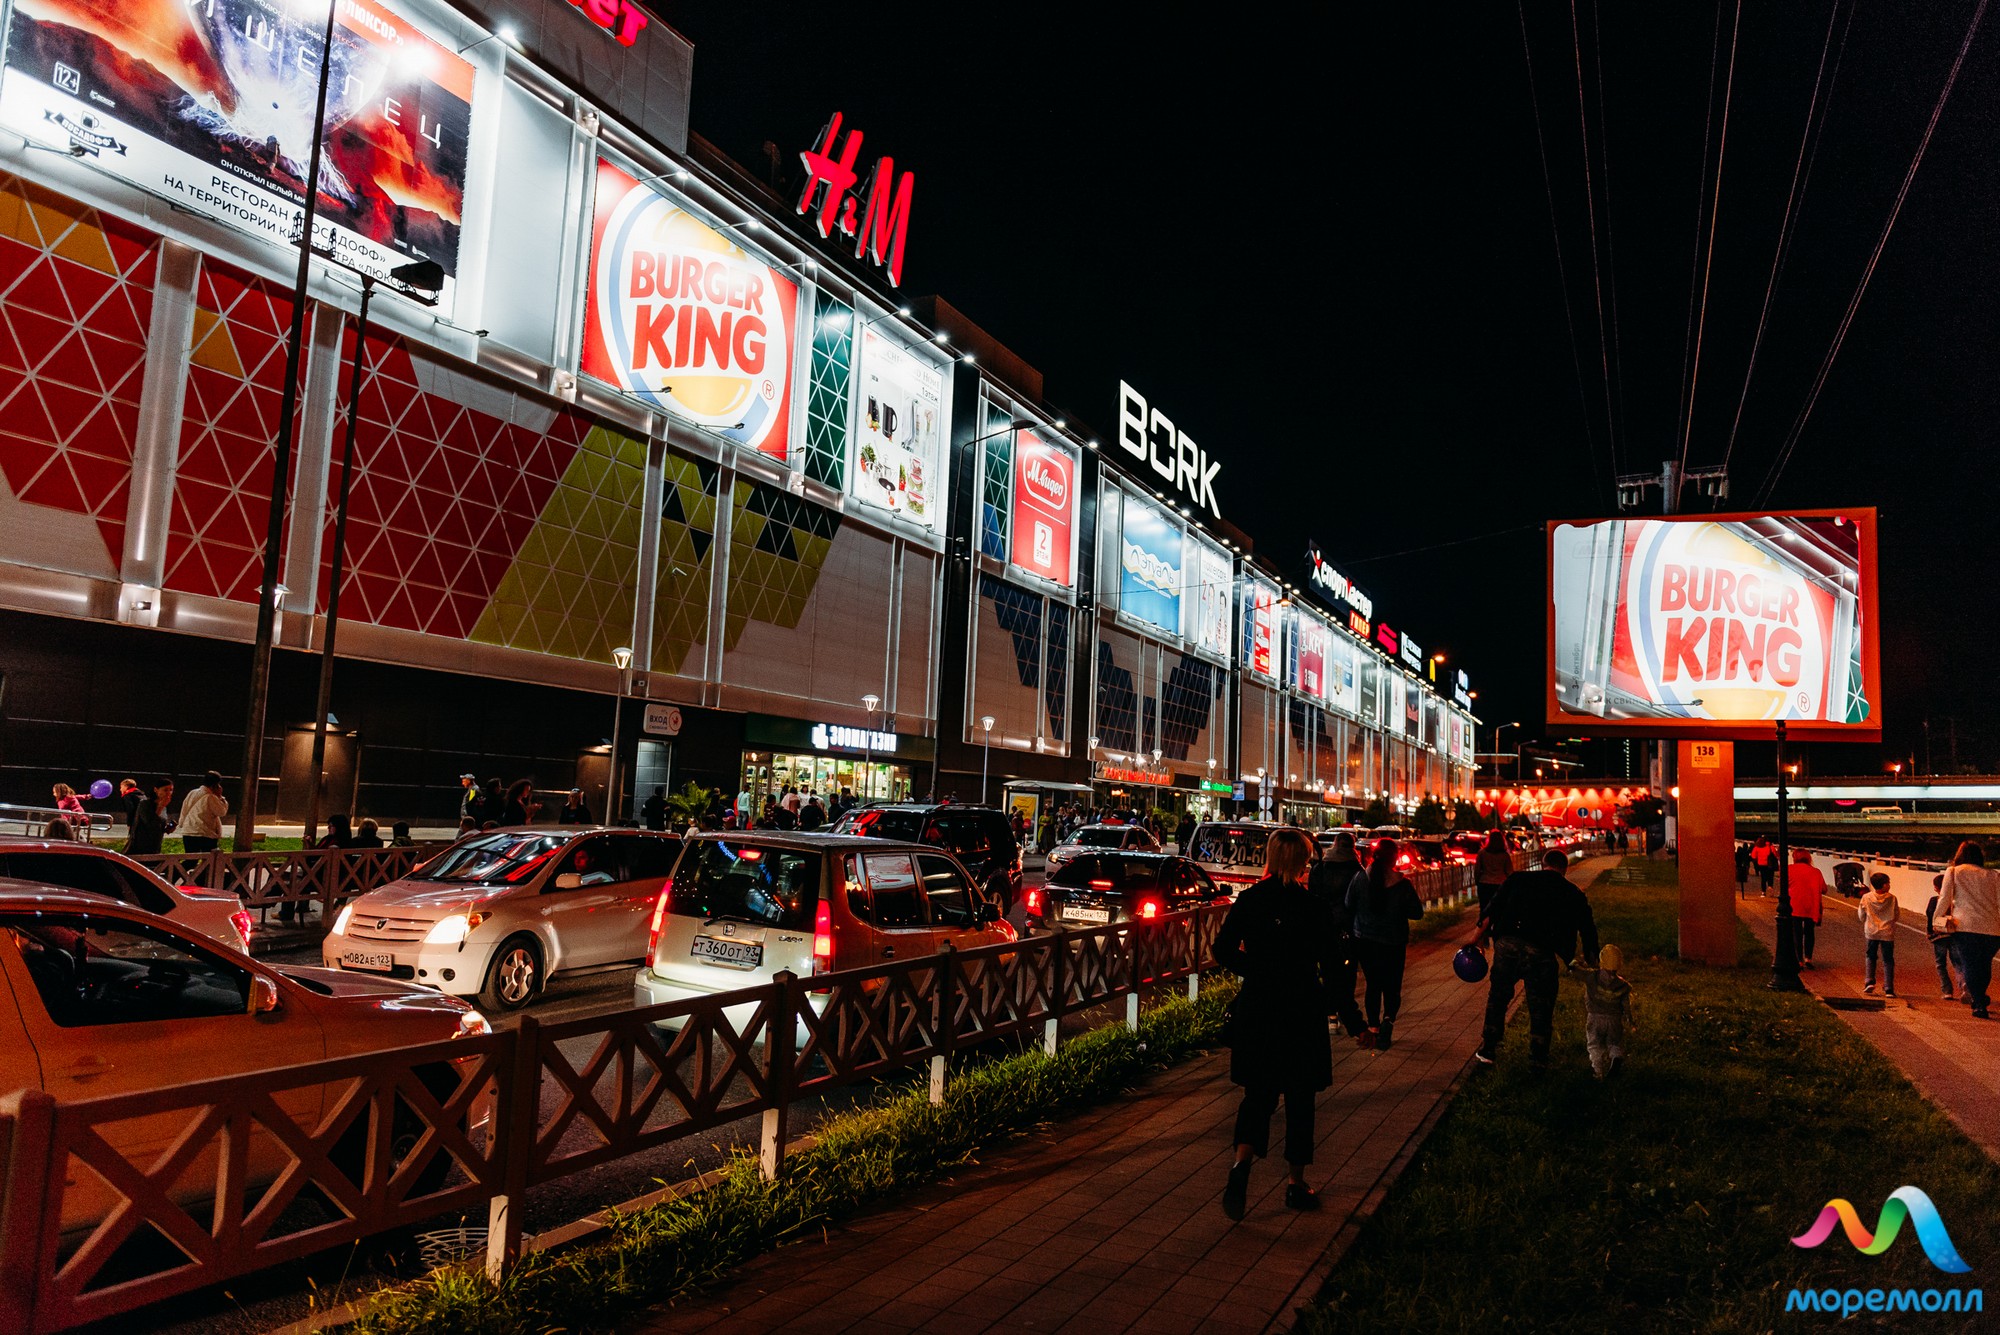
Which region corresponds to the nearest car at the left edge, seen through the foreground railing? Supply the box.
[0,881,490,1229]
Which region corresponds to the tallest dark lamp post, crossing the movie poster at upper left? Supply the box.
[236,0,340,853]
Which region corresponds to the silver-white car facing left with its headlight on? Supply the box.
[320,825,680,1011]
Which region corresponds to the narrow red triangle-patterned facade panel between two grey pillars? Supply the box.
[166,260,292,604]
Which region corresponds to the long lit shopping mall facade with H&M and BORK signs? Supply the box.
[0,0,1474,823]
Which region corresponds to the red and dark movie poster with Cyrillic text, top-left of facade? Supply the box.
[0,0,474,310]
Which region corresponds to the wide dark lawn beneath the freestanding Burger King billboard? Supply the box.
[1298,857,2000,1335]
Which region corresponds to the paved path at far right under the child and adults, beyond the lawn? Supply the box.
[1736,889,2000,1159]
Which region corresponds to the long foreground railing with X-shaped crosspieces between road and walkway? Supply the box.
[0,903,1226,1333]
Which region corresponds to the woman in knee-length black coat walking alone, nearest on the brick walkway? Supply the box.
[1216,829,1340,1219]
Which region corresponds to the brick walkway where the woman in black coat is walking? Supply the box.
[648,857,1612,1335]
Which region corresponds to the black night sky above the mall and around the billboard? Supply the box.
[658,0,2000,773]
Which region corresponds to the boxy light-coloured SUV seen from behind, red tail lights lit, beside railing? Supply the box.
[632,829,1014,1005]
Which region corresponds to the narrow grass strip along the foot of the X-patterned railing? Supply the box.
[354,979,1236,1335]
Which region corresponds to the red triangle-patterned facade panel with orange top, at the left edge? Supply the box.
[0,174,160,568]
